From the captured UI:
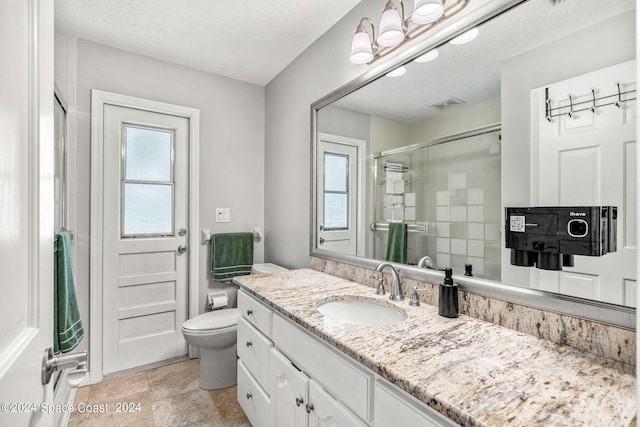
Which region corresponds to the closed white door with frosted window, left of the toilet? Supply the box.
[103,101,189,374]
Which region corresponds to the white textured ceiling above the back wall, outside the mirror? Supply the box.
[55,0,360,86]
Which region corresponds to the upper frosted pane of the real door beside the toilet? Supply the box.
[124,126,172,182]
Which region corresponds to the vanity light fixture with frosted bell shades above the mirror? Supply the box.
[349,0,471,64]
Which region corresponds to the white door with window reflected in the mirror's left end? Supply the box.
[316,134,365,255]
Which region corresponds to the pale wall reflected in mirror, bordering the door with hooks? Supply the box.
[501,12,635,285]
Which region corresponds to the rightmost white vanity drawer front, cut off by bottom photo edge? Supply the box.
[373,380,458,427]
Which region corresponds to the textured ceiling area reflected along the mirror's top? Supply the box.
[335,0,635,123]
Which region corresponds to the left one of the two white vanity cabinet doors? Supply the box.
[270,349,309,427]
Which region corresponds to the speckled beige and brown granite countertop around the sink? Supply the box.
[234,269,636,426]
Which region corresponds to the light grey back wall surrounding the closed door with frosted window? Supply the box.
[56,35,265,354]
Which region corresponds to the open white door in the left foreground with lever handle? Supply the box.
[0,0,54,426]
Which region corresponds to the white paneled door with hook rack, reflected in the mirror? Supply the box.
[531,61,637,305]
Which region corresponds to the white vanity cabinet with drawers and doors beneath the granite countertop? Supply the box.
[238,290,457,427]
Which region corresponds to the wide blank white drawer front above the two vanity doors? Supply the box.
[272,315,374,421]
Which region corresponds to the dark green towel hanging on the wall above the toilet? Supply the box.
[211,233,253,282]
